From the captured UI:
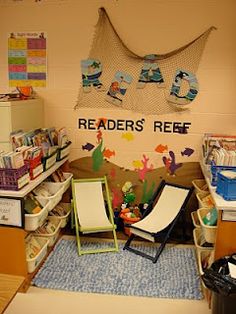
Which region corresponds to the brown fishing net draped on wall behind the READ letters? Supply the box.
[75,8,214,115]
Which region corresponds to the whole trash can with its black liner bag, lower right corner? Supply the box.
[202,253,236,314]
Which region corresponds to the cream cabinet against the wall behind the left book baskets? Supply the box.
[0,98,44,151]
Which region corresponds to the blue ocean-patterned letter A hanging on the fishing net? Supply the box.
[137,54,164,88]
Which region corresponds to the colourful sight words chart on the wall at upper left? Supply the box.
[8,32,47,87]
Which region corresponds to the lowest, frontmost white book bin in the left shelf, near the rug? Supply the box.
[25,233,49,273]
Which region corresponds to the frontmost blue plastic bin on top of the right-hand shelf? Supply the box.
[216,170,236,201]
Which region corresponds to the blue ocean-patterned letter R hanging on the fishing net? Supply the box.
[81,59,105,93]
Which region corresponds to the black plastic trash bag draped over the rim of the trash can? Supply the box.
[202,253,236,296]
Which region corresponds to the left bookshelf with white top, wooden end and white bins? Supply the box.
[0,157,72,290]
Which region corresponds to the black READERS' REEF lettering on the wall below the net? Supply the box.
[78,118,191,134]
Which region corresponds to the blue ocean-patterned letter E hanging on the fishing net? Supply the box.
[106,71,132,106]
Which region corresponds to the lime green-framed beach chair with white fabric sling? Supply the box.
[72,177,118,255]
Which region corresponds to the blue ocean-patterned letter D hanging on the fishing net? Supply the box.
[168,70,198,105]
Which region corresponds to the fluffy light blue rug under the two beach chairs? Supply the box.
[32,239,202,299]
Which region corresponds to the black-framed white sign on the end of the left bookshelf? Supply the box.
[0,197,24,228]
